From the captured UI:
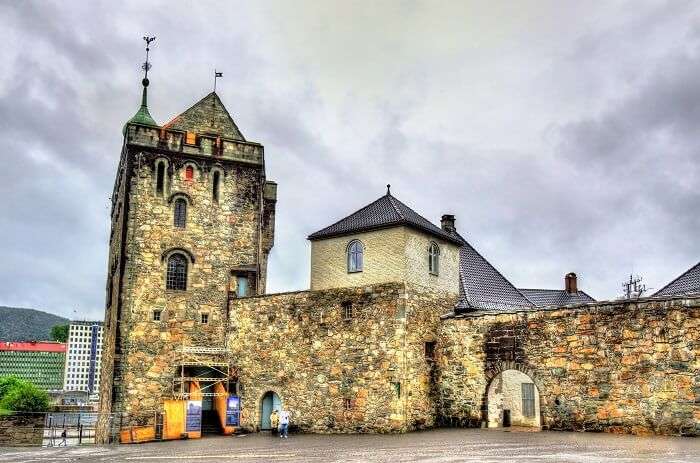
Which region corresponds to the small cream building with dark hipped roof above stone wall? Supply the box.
[309,187,464,294]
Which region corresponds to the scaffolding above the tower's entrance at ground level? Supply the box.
[173,346,235,400]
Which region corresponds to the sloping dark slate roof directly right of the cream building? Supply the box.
[456,240,533,310]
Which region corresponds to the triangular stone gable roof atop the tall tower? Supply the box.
[164,92,245,141]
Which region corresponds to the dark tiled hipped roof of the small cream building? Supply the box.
[308,192,462,246]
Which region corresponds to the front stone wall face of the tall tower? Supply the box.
[102,146,274,432]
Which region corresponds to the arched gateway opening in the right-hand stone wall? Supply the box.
[481,361,546,427]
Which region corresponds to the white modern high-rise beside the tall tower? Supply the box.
[63,321,102,402]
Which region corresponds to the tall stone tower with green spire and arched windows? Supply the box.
[98,70,277,442]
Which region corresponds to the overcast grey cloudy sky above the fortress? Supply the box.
[0,0,700,318]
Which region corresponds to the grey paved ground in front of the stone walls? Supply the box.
[0,429,700,463]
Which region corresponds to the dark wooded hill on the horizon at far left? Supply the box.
[0,306,68,341]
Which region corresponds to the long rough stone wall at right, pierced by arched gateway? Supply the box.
[438,298,700,435]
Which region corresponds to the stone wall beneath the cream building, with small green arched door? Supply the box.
[228,283,456,433]
